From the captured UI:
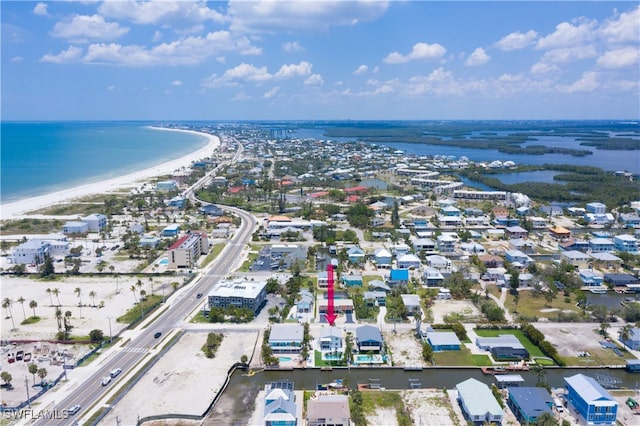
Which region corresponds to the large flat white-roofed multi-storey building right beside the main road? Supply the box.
[207,278,267,315]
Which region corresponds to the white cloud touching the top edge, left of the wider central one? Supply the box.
[98,0,226,24]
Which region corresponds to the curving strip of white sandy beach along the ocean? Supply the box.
[0,126,220,220]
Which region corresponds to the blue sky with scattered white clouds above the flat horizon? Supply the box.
[0,0,640,120]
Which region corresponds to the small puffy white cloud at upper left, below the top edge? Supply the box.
[51,15,129,43]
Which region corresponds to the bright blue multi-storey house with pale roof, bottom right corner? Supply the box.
[564,374,618,425]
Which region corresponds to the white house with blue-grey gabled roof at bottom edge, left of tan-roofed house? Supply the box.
[260,382,301,426]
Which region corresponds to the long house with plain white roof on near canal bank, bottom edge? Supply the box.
[456,379,504,425]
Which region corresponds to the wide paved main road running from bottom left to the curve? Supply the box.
[35,207,256,425]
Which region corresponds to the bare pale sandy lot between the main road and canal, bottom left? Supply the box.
[101,331,258,425]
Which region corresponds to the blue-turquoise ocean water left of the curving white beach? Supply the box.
[0,122,207,203]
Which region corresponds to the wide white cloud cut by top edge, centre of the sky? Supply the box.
[228,0,389,33]
